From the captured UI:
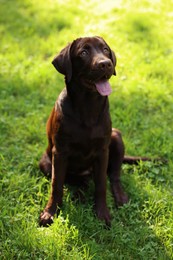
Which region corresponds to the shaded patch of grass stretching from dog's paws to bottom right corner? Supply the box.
[59,175,171,259]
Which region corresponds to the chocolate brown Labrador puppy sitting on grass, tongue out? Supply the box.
[40,37,147,226]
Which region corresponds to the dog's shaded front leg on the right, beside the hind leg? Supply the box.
[94,149,111,226]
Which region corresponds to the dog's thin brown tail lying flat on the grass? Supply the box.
[123,156,168,165]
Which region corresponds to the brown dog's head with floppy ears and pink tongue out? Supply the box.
[52,37,116,95]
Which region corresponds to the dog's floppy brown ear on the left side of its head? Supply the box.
[52,43,72,82]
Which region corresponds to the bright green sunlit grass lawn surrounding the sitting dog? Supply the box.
[0,0,173,260]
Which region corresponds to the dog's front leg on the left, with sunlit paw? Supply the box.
[40,149,67,226]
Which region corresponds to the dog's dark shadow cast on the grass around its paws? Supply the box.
[51,168,170,259]
